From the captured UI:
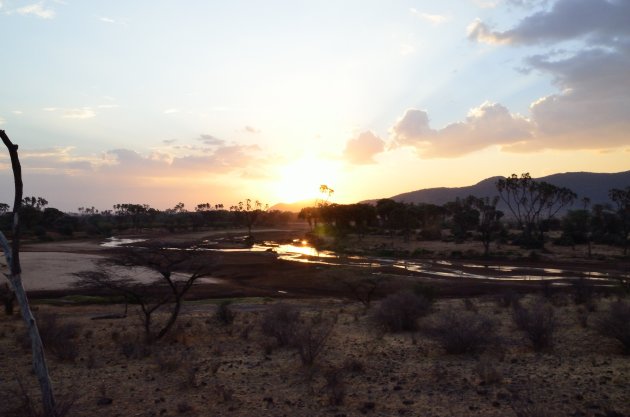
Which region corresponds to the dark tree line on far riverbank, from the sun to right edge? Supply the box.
[298,173,630,255]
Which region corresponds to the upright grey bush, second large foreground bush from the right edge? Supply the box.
[512,300,556,351]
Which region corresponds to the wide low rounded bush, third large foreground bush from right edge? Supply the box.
[428,310,497,354]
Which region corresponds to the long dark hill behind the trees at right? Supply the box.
[363,171,630,211]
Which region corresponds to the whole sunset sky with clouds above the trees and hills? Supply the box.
[0,0,630,211]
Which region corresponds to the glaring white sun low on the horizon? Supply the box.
[274,157,339,203]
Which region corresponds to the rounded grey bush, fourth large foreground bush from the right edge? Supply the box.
[374,292,431,332]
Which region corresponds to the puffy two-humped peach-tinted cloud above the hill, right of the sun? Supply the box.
[390,102,532,158]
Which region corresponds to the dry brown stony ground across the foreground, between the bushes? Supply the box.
[0,296,630,417]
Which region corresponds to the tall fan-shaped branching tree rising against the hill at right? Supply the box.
[496,173,577,247]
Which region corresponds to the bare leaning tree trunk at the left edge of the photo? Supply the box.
[0,130,57,417]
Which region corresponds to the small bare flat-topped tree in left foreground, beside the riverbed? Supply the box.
[75,242,215,343]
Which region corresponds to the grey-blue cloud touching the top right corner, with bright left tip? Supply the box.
[468,0,630,44]
